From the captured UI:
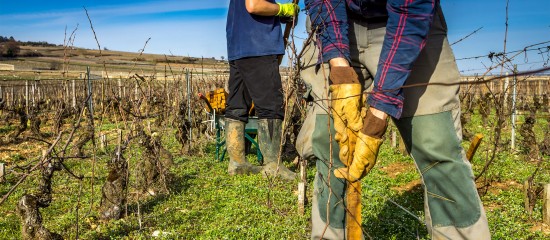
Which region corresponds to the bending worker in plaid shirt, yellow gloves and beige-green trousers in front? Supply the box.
[297,0,496,239]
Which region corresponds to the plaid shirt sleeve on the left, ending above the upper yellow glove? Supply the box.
[305,0,350,62]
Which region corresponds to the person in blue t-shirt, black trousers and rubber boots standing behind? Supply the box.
[225,0,299,180]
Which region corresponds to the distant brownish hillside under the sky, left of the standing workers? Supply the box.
[0,36,227,78]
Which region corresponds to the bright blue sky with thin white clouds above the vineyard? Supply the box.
[0,0,550,74]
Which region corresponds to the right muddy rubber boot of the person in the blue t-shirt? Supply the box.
[258,119,297,181]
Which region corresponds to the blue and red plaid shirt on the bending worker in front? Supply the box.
[305,0,439,118]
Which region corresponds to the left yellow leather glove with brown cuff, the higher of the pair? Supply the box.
[329,67,364,166]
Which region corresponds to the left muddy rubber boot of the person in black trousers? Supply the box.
[225,118,262,176]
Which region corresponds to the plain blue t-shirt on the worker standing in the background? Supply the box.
[226,0,285,61]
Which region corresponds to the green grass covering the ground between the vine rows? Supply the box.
[0,113,549,239]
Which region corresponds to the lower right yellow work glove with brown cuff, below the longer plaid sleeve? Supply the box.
[334,107,388,182]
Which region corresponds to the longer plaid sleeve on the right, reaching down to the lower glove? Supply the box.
[368,0,439,118]
